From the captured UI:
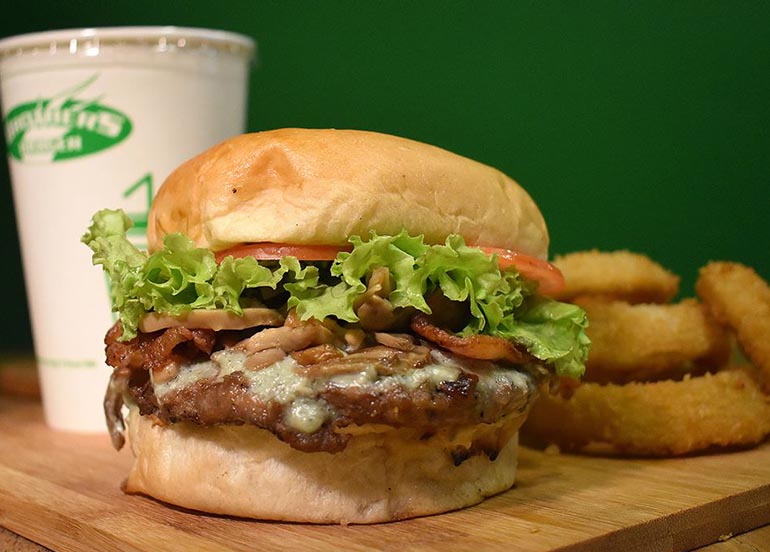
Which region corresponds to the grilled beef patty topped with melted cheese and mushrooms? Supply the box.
[105,316,537,454]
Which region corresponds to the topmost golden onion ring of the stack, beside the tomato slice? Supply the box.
[553,249,679,303]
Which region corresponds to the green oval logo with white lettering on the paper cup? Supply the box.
[5,73,132,163]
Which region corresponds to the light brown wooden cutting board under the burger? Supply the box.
[0,396,770,552]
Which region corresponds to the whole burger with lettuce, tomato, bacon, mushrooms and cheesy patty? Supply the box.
[83,129,589,524]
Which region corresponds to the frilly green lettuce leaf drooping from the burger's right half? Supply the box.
[320,231,590,378]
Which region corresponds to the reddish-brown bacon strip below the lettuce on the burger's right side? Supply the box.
[411,314,534,364]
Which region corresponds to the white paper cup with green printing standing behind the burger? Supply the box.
[0,27,255,432]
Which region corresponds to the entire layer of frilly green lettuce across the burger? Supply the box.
[82,210,590,377]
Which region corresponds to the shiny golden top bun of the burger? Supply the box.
[148,129,548,259]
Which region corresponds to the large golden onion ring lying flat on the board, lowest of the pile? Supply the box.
[522,365,770,457]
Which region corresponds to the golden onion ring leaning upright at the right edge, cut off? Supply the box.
[695,262,770,391]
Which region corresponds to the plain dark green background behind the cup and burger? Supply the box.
[0,0,770,350]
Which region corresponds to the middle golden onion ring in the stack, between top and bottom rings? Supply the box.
[575,297,730,383]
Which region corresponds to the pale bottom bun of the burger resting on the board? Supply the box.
[125,408,523,524]
